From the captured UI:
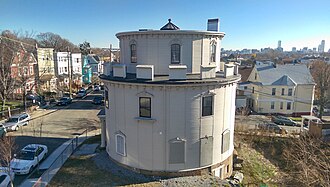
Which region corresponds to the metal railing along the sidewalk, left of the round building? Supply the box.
[33,129,88,187]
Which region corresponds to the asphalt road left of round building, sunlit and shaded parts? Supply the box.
[8,91,102,186]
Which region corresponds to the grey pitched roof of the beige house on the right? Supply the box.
[256,64,314,86]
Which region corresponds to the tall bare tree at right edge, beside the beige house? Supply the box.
[311,60,330,119]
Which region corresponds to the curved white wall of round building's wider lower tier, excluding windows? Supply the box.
[104,80,236,171]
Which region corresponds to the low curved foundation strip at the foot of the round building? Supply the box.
[109,155,233,179]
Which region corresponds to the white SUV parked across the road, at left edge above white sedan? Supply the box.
[3,113,31,131]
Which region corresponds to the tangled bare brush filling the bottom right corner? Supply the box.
[283,135,330,186]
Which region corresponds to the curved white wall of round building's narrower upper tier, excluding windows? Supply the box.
[117,31,224,75]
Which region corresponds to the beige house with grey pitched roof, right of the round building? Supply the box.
[244,61,315,116]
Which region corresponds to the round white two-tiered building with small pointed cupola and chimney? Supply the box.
[100,20,240,178]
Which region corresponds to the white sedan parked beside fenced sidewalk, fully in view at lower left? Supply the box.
[10,144,48,175]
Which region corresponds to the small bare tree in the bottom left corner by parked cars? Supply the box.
[0,136,16,186]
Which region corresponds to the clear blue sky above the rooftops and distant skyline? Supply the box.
[0,0,330,50]
